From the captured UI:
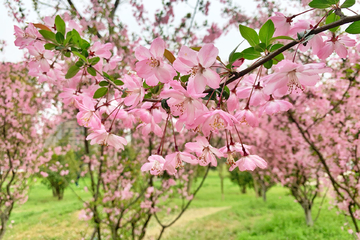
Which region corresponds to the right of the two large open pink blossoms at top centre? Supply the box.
[173,44,221,93]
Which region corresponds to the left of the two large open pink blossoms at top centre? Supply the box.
[135,38,176,86]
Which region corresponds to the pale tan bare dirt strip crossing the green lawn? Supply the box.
[145,207,230,240]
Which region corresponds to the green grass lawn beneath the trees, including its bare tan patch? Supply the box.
[5,171,353,240]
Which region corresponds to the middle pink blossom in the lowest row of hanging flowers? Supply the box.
[185,136,223,167]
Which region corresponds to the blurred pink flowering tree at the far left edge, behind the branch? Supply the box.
[0,63,51,238]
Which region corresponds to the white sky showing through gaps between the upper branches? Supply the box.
[0,0,262,62]
